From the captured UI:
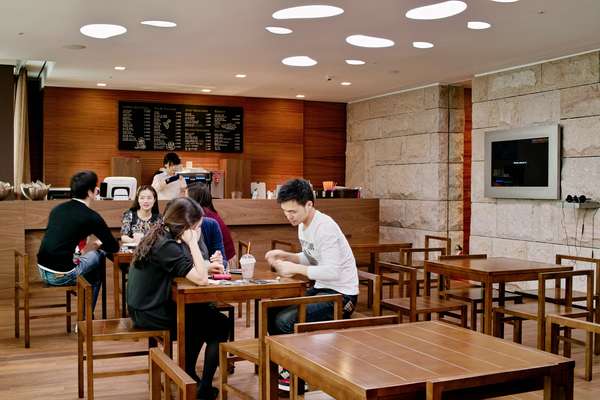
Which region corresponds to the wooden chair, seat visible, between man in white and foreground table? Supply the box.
[219,294,343,400]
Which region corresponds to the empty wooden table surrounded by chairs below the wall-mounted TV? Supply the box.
[425,257,573,335]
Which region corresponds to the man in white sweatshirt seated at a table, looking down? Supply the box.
[265,179,358,334]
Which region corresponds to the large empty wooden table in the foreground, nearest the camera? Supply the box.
[266,321,575,400]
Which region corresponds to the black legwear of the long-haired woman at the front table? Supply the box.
[129,303,229,388]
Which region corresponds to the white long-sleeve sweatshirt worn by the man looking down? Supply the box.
[298,211,358,295]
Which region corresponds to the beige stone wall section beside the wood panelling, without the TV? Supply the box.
[346,86,464,252]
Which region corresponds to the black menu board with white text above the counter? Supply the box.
[119,101,244,153]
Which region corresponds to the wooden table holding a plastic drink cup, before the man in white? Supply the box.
[172,271,306,368]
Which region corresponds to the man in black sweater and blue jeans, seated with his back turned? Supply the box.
[37,171,119,307]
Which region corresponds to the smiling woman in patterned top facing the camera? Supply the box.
[121,185,161,243]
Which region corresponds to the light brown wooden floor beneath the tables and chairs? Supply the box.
[0,290,600,400]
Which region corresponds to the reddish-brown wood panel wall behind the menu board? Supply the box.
[43,87,346,189]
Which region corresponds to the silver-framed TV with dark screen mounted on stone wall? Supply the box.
[484,124,561,199]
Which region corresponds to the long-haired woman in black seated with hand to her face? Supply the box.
[127,198,229,400]
